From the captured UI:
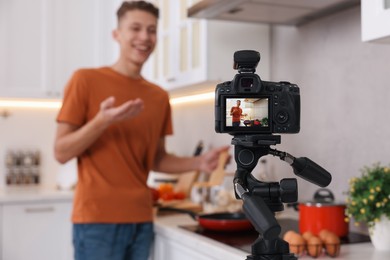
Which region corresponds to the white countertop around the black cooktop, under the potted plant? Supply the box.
[155,214,390,260]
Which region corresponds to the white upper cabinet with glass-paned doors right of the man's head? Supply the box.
[144,0,270,93]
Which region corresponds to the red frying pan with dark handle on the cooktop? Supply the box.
[159,207,253,231]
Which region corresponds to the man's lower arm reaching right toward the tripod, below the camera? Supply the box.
[153,138,229,173]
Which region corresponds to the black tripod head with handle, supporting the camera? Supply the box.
[232,135,331,260]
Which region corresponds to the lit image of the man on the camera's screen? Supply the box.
[226,98,269,128]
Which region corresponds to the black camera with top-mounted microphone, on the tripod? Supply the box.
[215,50,301,135]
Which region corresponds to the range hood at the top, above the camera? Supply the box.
[188,0,360,26]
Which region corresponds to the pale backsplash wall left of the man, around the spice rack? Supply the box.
[0,108,59,188]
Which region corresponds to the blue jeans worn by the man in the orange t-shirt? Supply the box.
[73,222,154,260]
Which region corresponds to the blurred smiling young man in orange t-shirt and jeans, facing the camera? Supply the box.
[55,1,227,260]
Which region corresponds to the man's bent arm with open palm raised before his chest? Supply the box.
[54,97,143,163]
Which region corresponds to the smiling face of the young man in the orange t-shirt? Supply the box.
[113,10,157,66]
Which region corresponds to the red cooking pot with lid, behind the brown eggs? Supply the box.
[298,189,349,237]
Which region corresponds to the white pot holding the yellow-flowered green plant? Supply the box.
[368,215,390,251]
